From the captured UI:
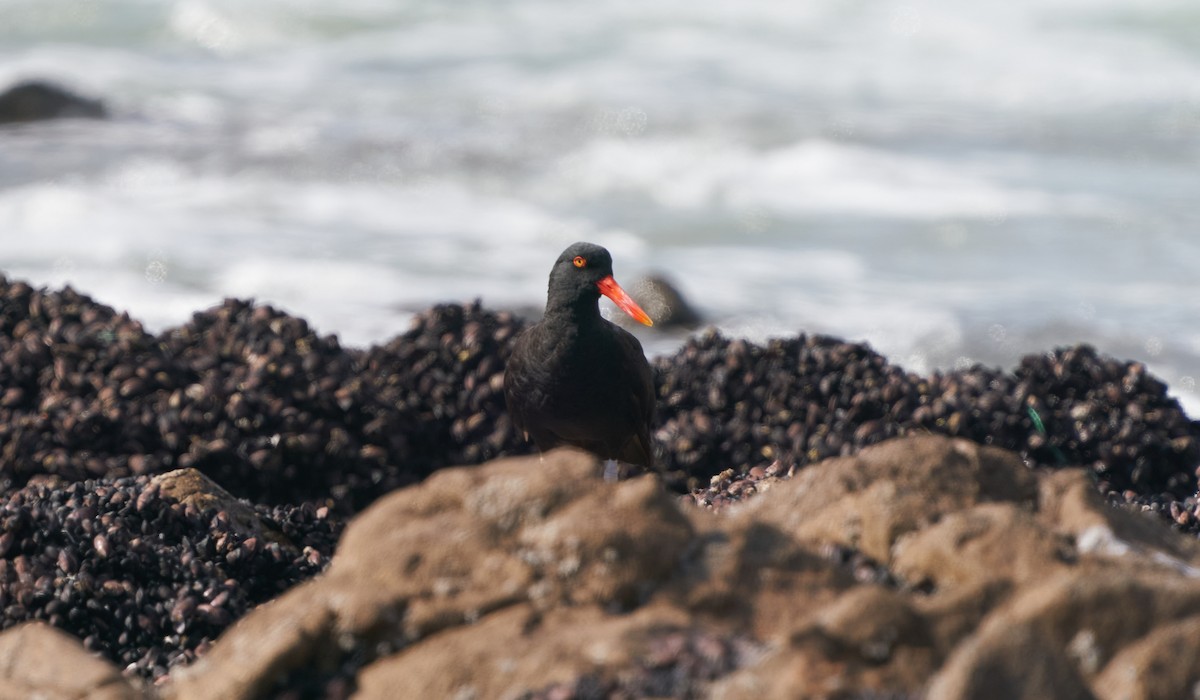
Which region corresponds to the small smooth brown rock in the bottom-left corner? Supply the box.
[0,622,148,700]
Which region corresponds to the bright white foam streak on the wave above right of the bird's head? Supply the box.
[552,139,1105,220]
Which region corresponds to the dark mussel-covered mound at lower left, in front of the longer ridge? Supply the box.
[0,474,341,678]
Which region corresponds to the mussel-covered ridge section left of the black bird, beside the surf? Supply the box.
[0,281,528,515]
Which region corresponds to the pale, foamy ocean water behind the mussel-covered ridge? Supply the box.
[0,0,1200,415]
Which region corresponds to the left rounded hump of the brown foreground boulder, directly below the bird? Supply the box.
[169,450,690,699]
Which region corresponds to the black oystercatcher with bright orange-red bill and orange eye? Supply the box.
[504,243,654,478]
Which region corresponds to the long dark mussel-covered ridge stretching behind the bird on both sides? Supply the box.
[0,273,1200,521]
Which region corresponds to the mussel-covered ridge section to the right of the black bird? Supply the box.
[655,331,1200,504]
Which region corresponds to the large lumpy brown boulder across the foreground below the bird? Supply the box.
[9,436,1200,700]
